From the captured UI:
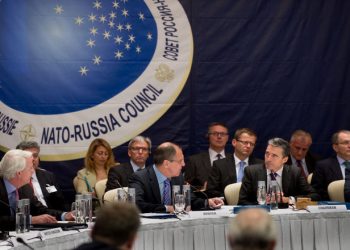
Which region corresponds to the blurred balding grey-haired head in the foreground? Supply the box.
[228,208,277,250]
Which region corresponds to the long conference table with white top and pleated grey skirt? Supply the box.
[0,206,350,250]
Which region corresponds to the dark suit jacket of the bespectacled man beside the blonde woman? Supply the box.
[106,162,134,192]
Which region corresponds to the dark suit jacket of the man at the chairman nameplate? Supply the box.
[238,164,319,205]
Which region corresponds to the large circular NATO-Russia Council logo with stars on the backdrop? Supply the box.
[0,0,193,161]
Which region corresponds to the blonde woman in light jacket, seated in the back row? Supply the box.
[74,138,117,196]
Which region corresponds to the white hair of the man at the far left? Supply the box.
[0,149,32,180]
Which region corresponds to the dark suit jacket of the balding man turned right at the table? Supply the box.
[129,166,206,213]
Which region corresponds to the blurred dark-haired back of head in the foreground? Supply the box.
[91,202,140,247]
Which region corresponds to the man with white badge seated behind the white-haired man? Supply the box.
[16,141,68,211]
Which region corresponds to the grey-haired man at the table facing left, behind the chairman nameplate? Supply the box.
[238,138,319,205]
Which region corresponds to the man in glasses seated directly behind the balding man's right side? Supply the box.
[184,122,229,190]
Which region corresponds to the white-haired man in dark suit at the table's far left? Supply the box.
[0,149,74,230]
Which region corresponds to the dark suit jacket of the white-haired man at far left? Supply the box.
[0,177,62,230]
